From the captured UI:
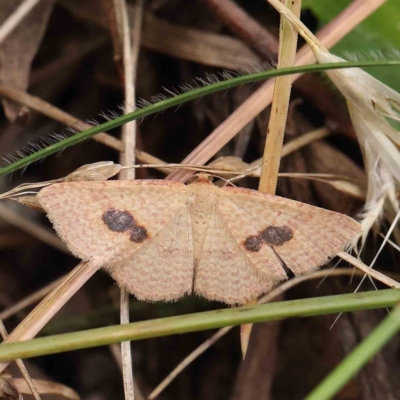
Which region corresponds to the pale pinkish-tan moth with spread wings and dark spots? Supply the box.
[37,173,360,305]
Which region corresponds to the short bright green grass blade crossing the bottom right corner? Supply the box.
[306,304,400,400]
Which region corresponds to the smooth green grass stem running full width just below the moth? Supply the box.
[0,289,400,362]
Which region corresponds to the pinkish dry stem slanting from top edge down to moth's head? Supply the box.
[167,0,376,182]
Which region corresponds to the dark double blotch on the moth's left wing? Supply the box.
[103,208,149,243]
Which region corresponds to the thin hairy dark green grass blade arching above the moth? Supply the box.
[0,60,400,177]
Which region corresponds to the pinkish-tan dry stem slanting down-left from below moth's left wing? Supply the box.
[0,261,98,372]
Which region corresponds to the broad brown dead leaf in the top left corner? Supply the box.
[0,0,54,122]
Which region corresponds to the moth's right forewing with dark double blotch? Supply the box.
[221,188,361,275]
